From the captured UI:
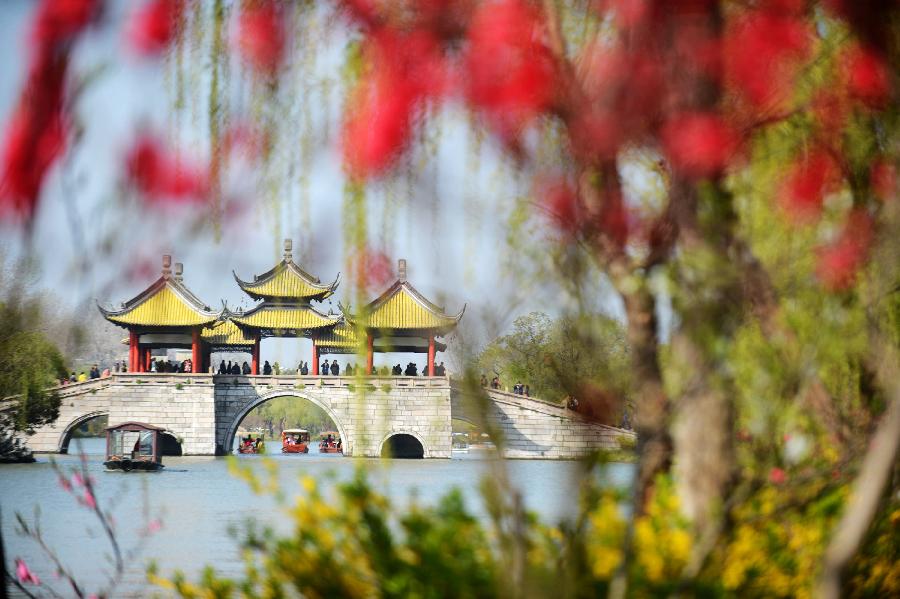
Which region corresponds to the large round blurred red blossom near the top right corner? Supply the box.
[723,10,812,108]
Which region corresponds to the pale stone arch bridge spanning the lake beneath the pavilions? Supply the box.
[22,373,634,459]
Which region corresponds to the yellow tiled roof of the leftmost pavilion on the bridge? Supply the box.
[103,282,217,327]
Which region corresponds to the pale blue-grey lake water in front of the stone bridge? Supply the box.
[0,439,633,597]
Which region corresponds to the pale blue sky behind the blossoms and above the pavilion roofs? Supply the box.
[0,0,622,365]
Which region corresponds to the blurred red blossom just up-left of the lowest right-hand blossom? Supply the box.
[779,151,840,222]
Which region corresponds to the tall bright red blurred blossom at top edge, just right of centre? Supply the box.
[465,0,556,139]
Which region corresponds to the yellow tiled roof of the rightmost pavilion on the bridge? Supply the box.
[364,282,459,329]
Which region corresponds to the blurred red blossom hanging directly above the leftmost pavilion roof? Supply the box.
[125,135,209,201]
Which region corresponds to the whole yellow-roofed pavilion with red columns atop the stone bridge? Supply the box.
[98,239,465,376]
